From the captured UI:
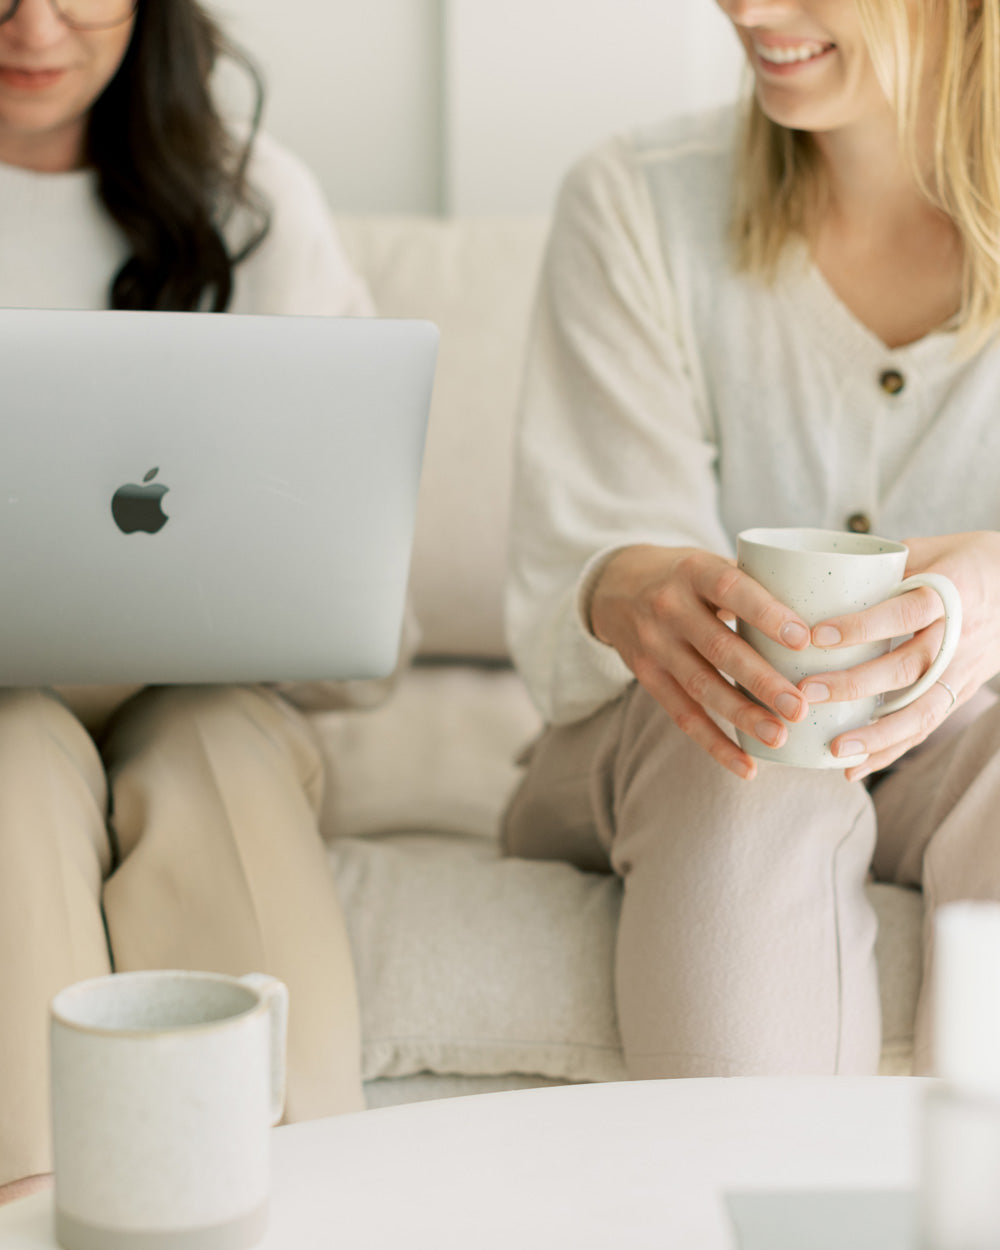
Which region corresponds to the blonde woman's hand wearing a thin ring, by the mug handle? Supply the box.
[799,530,1000,781]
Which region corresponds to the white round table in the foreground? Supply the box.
[0,1076,931,1250]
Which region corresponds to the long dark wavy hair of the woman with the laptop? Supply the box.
[88,0,270,313]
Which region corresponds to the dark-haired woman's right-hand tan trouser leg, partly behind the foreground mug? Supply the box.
[105,688,364,1120]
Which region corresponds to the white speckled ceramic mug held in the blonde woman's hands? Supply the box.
[736,529,961,769]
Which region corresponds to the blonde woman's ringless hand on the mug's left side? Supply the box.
[590,546,810,780]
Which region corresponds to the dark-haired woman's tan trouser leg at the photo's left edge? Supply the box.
[0,690,111,1185]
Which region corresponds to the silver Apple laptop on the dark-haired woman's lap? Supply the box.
[0,309,438,685]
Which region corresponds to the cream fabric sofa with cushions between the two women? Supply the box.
[305,216,923,1106]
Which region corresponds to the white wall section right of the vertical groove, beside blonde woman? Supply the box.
[444,0,743,213]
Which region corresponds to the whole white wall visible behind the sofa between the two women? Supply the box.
[213,0,741,213]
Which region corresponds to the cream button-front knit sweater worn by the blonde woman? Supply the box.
[506,110,1000,723]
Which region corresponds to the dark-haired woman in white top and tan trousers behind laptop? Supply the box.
[0,0,382,1200]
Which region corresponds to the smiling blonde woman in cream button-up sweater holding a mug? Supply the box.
[505,0,1000,1078]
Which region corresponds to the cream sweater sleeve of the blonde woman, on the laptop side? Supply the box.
[505,140,730,724]
